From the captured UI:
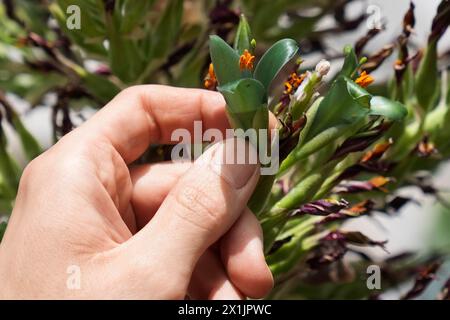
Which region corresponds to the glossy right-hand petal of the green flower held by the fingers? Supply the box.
[254,39,299,91]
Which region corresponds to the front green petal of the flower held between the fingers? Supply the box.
[218,78,268,130]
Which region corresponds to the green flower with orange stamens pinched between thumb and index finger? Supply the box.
[208,15,299,134]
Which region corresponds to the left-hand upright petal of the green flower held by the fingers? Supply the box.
[209,36,242,85]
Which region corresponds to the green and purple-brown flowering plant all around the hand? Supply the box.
[0,0,450,299]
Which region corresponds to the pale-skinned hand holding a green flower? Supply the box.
[0,86,273,299]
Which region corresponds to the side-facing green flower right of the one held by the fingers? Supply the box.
[280,48,407,176]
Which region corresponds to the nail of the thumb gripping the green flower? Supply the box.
[211,139,259,189]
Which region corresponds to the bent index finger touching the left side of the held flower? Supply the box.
[80,85,229,163]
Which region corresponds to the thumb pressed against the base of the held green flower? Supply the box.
[122,139,259,284]
